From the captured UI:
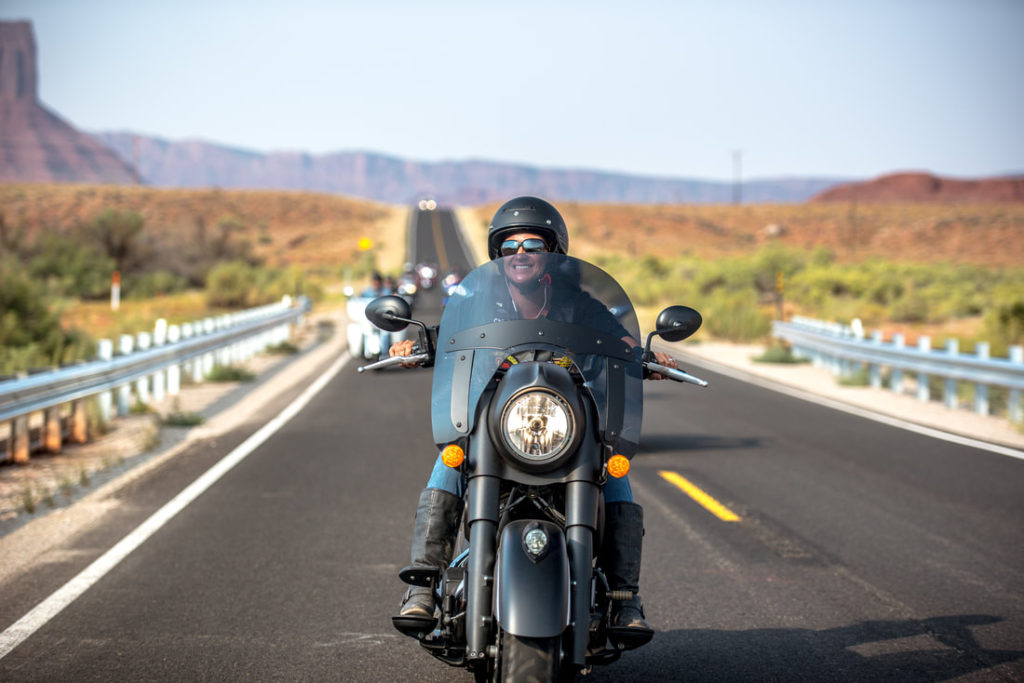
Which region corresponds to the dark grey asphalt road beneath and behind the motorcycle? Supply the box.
[0,211,1024,681]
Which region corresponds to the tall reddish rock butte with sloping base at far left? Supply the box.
[0,22,135,183]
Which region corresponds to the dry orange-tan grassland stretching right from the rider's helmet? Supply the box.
[467,202,1024,266]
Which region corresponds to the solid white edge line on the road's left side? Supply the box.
[0,353,351,659]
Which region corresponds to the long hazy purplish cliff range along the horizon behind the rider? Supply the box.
[90,133,841,205]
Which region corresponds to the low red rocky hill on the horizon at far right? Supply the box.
[811,173,1024,204]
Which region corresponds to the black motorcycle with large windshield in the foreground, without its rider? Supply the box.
[359,253,707,681]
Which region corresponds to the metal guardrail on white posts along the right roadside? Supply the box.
[772,316,1024,423]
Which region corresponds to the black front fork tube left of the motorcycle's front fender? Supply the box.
[466,476,501,661]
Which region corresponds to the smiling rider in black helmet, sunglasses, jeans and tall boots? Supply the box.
[389,197,676,643]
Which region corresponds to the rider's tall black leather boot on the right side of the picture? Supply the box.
[599,502,654,648]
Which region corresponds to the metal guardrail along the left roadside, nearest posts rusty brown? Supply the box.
[0,297,309,462]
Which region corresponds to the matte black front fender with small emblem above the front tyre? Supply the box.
[495,519,569,638]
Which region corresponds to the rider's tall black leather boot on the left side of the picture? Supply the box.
[392,488,462,635]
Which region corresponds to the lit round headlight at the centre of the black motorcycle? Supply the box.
[501,391,572,462]
